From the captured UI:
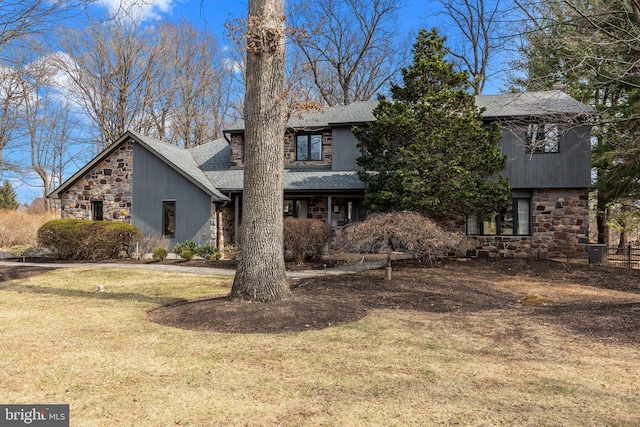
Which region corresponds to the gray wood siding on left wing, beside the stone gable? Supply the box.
[132,144,211,246]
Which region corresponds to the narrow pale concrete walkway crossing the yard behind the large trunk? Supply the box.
[0,259,385,280]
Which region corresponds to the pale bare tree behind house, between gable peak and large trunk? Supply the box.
[146,22,238,148]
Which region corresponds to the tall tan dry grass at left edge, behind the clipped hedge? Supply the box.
[0,210,59,248]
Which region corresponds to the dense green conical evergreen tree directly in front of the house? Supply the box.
[354,29,511,218]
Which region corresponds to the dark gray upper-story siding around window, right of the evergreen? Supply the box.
[501,126,591,188]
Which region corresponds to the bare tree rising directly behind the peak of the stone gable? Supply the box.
[58,20,156,148]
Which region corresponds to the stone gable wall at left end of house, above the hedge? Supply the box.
[61,141,133,223]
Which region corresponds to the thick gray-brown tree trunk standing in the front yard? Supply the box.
[230,0,291,302]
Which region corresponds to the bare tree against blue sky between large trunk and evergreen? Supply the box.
[289,0,408,105]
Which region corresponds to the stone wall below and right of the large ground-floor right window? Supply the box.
[469,188,589,258]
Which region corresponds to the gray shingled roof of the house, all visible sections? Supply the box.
[52,91,593,200]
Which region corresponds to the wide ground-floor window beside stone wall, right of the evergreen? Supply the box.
[467,198,531,236]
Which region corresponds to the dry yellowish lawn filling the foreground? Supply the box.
[0,269,640,426]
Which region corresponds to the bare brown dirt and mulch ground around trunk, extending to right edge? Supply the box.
[0,259,640,346]
